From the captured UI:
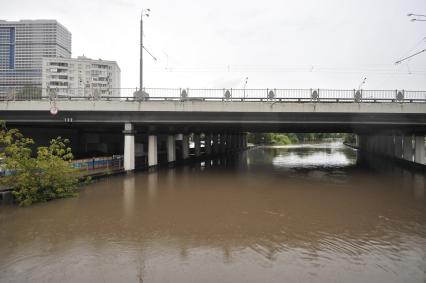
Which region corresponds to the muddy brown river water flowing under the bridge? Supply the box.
[0,143,426,283]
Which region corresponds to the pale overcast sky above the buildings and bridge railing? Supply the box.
[0,0,426,90]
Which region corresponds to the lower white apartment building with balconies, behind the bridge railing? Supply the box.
[41,56,120,96]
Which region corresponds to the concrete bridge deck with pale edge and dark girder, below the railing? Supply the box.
[0,100,426,132]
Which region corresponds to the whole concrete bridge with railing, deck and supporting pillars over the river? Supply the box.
[0,88,426,170]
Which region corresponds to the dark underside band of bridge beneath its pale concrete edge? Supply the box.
[1,111,426,134]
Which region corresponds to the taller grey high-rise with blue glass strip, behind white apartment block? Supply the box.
[0,20,71,88]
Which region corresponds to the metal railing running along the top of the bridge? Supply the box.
[0,87,426,103]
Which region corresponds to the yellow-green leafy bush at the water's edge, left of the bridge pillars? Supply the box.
[0,123,78,206]
